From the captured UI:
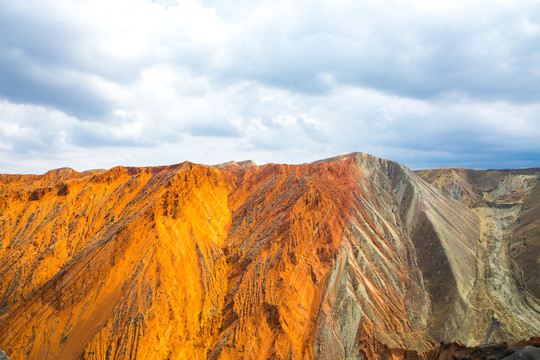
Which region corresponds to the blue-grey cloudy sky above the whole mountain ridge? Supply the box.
[0,0,540,174]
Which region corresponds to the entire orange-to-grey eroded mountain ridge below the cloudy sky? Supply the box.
[0,153,540,360]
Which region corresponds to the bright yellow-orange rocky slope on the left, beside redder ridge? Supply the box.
[0,164,231,359]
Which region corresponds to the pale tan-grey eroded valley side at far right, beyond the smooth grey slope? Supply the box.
[416,168,540,344]
